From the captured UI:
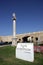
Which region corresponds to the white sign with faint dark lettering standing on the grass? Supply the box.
[16,43,34,62]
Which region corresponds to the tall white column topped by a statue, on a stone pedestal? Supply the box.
[12,13,17,46]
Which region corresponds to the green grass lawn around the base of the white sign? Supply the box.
[0,46,43,65]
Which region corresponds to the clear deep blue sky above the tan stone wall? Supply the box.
[0,0,43,36]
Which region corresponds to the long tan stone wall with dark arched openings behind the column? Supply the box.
[0,31,43,42]
